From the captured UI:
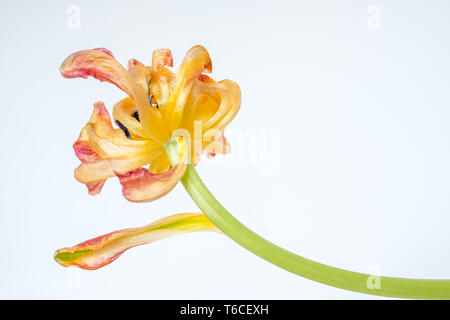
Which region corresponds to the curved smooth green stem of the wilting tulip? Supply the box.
[166,142,450,299]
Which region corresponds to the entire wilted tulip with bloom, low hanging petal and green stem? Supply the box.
[55,46,450,299]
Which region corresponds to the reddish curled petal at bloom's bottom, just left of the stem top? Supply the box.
[116,138,188,202]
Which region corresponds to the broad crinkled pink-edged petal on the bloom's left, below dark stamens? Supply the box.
[74,102,162,195]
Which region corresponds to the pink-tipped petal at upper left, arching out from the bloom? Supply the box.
[59,48,133,97]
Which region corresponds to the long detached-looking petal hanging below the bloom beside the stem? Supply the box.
[54,213,219,270]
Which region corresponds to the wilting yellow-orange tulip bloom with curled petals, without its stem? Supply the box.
[60,46,241,202]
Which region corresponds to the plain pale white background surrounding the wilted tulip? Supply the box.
[0,0,450,299]
